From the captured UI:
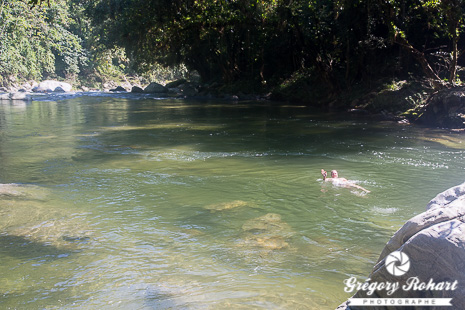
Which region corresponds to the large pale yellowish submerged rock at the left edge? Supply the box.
[0,184,93,251]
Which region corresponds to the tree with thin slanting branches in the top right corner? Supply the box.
[386,0,465,88]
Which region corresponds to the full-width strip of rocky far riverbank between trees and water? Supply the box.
[0,79,465,131]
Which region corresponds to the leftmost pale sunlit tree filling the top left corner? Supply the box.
[0,0,88,79]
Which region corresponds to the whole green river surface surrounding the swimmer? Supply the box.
[0,97,465,309]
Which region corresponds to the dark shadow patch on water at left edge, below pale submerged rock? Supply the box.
[0,235,73,260]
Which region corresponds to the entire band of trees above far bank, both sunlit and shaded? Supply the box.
[0,0,465,104]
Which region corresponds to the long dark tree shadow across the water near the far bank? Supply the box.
[68,100,410,161]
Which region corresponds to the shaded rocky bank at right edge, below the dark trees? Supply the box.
[337,80,465,132]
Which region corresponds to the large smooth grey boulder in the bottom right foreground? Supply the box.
[338,183,465,310]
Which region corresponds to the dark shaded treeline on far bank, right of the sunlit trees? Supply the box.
[0,0,465,94]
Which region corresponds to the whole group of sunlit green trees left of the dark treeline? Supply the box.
[0,0,179,86]
